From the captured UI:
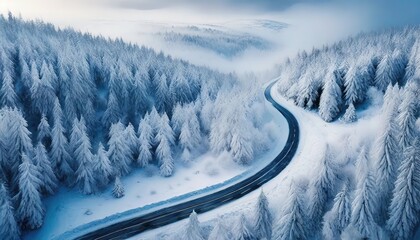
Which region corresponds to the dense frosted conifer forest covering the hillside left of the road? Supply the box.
[0,15,270,239]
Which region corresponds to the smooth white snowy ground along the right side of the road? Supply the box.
[132,79,388,240]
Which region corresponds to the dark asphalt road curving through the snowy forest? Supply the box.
[76,82,299,240]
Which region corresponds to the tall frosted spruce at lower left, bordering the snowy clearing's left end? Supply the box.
[15,153,45,229]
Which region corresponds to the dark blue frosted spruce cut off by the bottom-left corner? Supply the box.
[0,183,20,240]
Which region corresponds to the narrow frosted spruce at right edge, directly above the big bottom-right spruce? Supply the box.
[397,87,416,148]
